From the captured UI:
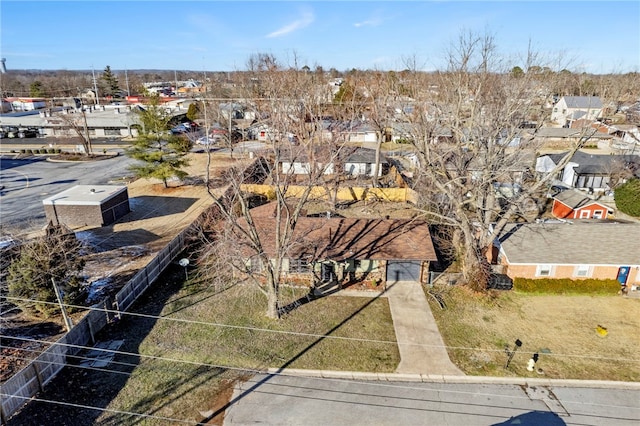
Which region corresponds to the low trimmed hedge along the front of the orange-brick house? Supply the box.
[513,278,620,294]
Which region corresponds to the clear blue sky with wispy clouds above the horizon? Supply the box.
[0,0,640,73]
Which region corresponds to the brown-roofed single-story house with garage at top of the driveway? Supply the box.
[238,204,437,285]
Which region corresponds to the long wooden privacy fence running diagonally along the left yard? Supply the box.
[0,228,190,424]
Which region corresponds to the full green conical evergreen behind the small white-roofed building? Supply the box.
[126,95,193,188]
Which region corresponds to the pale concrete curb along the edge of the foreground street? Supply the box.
[267,368,640,390]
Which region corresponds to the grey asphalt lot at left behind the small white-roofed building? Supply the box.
[0,154,133,236]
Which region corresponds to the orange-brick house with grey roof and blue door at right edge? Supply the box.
[494,220,640,285]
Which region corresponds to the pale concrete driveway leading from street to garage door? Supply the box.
[385,281,464,375]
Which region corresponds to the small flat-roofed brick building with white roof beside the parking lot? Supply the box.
[42,185,131,228]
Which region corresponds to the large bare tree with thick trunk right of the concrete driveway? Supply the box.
[404,33,589,289]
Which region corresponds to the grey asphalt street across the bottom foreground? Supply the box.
[224,376,640,426]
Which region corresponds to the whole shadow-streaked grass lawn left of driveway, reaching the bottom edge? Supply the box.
[95,278,400,425]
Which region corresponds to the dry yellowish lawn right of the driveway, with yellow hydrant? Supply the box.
[430,287,640,381]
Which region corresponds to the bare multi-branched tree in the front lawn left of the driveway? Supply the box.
[199,55,344,318]
